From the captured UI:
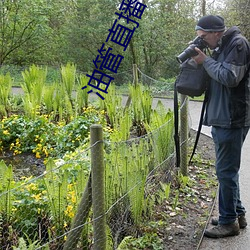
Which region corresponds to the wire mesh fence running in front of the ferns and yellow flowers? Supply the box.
[0,64,187,250]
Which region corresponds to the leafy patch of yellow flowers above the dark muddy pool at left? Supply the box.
[0,107,102,158]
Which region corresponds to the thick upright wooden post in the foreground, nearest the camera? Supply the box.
[90,124,106,250]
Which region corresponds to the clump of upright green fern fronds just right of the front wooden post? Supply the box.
[105,135,152,234]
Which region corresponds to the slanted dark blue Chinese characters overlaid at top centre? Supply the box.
[82,0,147,100]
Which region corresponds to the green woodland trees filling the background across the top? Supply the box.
[0,0,250,82]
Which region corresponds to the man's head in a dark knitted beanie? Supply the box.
[195,15,225,49]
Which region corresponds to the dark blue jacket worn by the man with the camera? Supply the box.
[203,27,250,128]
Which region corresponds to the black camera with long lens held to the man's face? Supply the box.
[176,36,208,63]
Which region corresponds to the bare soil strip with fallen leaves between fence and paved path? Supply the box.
[158,131,218,250]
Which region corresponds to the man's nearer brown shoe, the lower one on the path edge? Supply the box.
[204,222,240,238]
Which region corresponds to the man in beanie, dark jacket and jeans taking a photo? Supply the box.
[193,15,250,238]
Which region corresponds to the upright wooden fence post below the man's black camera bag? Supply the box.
[180,94,188,176]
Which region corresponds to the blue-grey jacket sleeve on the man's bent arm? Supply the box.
[203,38,250,88]
